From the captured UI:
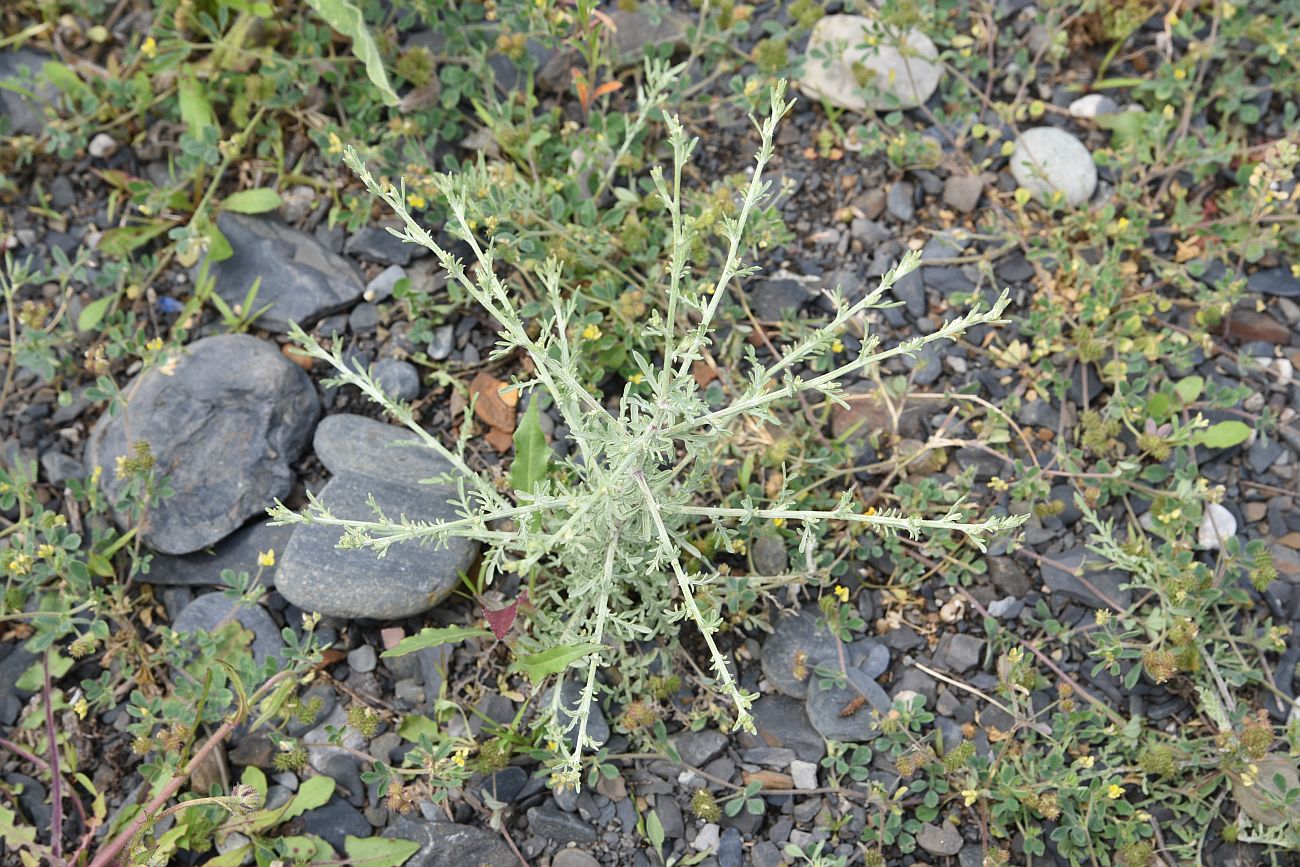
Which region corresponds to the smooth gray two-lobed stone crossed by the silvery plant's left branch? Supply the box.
[276,415,476,620]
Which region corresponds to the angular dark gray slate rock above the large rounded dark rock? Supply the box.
[208,212,365,331]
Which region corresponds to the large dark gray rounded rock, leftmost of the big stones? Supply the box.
[86,334,320,554]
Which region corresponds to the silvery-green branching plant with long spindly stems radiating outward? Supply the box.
[273,64,1022,785]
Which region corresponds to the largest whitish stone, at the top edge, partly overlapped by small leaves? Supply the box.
[800,16,944,112]
